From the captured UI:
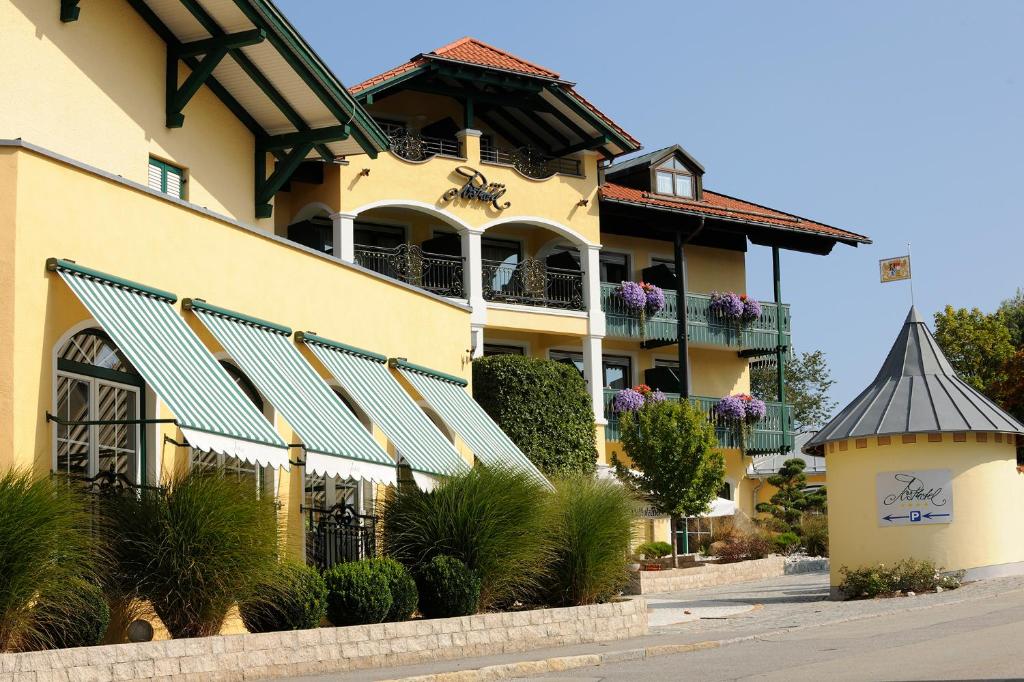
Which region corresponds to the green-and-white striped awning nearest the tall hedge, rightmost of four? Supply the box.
[391,358,550,485]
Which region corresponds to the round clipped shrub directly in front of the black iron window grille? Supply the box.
[324,560,392,626]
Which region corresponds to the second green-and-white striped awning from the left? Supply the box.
[183,299,396,483]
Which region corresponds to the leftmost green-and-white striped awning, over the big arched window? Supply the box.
[46,258,288,469]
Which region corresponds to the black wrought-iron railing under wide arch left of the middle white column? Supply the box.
[355,244,464,298]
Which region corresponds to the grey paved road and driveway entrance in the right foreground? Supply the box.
[291,573,1024,682]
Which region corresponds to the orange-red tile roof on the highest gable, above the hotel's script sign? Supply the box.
[348,37,641,150]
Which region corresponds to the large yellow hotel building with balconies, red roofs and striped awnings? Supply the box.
[0,0,867,552]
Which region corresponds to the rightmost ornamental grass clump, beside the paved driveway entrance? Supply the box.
[543,476,630,606]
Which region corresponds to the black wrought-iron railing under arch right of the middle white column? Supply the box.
[482,258,584,310]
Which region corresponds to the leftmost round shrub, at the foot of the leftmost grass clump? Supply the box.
[35,579,111,649]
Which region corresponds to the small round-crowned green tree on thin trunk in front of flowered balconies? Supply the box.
[611,400,725,565]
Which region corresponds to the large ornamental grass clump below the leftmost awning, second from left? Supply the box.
[106,468,281,638]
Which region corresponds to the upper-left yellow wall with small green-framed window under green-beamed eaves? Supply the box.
[0,0,272,229]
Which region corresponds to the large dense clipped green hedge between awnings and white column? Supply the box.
[473,355,597,475]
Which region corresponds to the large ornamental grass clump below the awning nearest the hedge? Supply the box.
[381,466,552,609]
